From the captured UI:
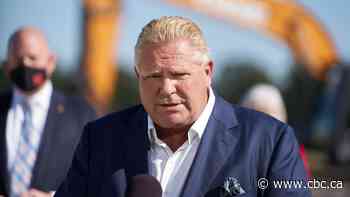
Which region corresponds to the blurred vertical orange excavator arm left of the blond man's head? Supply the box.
[81,0,121,114]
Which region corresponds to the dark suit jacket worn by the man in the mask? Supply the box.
[0,91,95,194]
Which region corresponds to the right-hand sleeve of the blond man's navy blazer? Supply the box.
[263,126,311,197]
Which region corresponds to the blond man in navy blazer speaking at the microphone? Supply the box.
[56,17,310,197]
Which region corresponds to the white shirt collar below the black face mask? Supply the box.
[13,80,53,109]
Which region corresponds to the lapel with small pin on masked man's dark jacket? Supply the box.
[31,91,64,186]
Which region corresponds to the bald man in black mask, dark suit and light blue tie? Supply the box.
[0,27,95,197]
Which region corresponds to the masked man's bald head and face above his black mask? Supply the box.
[5,32,55,76]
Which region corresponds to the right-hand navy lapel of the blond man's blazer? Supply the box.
[181,96,240,197]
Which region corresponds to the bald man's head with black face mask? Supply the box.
[5,28,56,95]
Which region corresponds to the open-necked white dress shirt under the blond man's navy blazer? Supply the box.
[148,88,215,197]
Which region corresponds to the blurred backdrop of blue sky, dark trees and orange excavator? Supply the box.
[0,0,350,196]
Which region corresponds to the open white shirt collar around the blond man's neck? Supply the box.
[147,87,215,144]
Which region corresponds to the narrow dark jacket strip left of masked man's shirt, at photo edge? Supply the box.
[0,91,12,194]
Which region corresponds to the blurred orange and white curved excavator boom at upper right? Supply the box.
[167,0,338,79]
